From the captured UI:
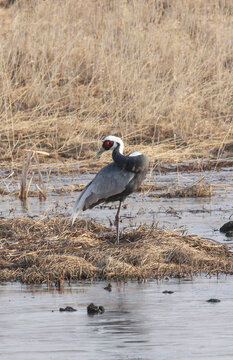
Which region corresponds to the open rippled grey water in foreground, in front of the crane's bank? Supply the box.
[0,277,233,360]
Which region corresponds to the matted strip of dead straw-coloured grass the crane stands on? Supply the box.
[0,218,233,284]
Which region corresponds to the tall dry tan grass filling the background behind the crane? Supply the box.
[0,0,233,166]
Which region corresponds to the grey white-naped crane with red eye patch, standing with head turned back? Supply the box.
[72,135,149,244]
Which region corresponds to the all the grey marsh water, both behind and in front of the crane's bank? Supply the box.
[0,168,233,360]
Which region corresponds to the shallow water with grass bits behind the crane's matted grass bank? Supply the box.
[0,168,233,244]
